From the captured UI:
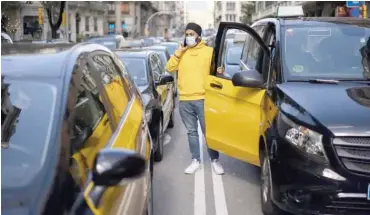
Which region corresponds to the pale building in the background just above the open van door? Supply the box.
[214,1,243,27]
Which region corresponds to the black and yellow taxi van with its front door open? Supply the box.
[205,7,370,215]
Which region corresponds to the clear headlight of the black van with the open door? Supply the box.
[281,115,326,160]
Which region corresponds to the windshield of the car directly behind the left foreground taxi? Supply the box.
[121,57,148,86]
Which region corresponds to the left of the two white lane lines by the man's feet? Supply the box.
[194,123,207,215]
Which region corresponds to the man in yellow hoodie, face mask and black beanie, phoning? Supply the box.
[166,23,224,174]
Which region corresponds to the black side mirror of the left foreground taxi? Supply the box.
[92,149,147,186]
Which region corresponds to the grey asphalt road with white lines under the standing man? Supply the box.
[153,110,262,215]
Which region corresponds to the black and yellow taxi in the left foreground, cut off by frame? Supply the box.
[1,43,153,215]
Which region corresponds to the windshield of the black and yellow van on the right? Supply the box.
[282,23,370,80]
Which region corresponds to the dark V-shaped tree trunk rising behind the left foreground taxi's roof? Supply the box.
[42,1,66,39]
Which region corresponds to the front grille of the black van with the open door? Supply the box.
[333,137,370,175]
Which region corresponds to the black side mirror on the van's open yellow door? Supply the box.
[231,69,265,88]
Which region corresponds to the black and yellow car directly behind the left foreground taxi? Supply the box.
[115,50,176,161]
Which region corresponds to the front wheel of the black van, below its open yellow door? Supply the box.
[260,152,281,215]
